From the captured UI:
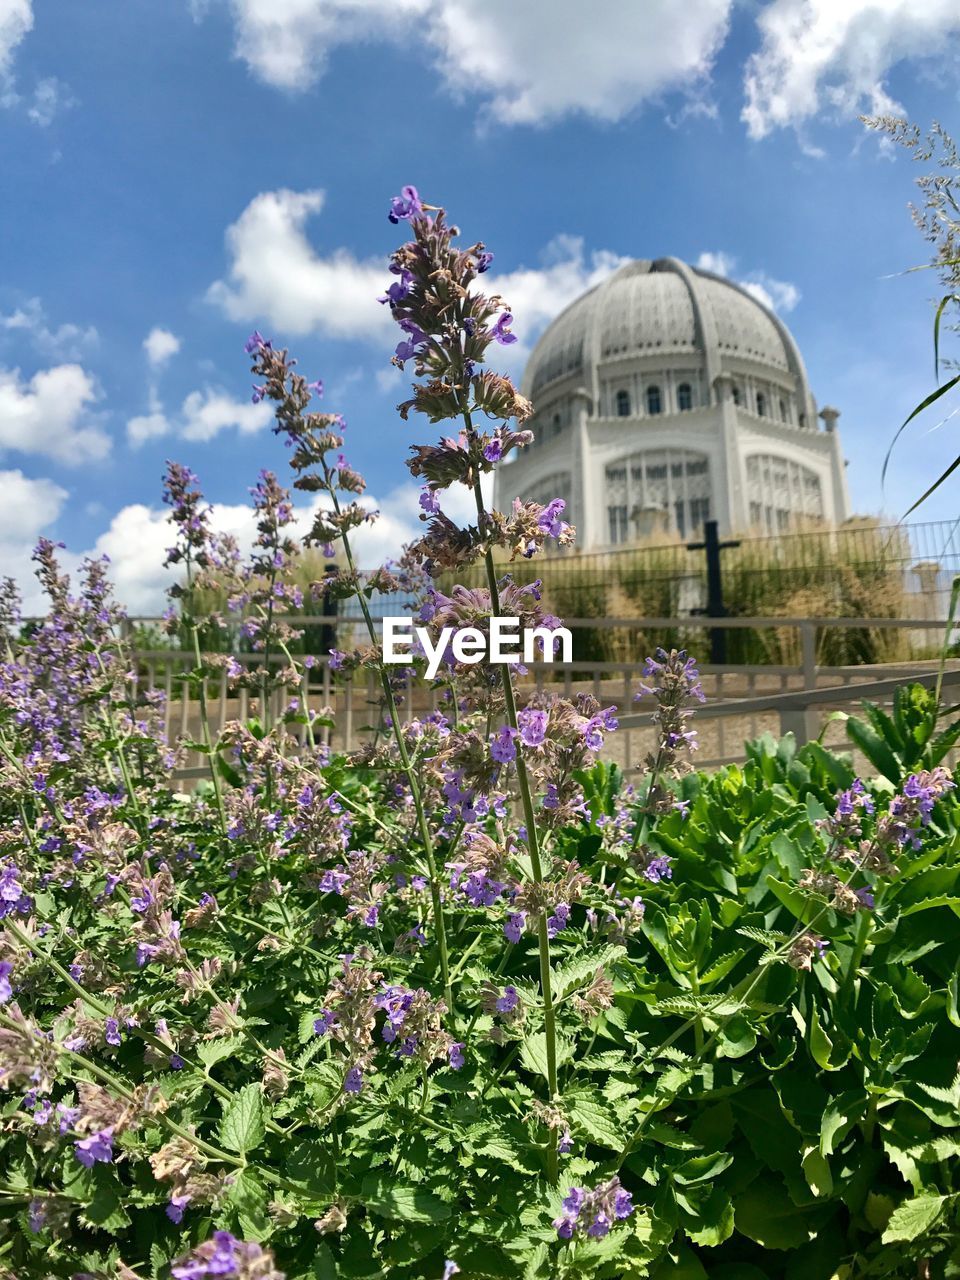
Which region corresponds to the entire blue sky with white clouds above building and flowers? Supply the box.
[0,0,960,611]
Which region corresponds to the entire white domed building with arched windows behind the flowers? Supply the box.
[494,257,849,550]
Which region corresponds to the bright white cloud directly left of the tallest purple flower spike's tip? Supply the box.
[207,189,393,338]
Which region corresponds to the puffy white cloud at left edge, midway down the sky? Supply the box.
[0,365,110,466]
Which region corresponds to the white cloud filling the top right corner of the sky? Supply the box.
[741,0,960,138]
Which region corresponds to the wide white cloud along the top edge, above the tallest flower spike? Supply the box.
[221,0,732,124]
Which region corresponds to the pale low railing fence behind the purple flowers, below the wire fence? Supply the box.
[114,617,960,782]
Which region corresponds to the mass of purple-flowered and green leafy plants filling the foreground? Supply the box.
[0,188,960,1280]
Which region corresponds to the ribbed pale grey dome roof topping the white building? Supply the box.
[524,257,808,398]
